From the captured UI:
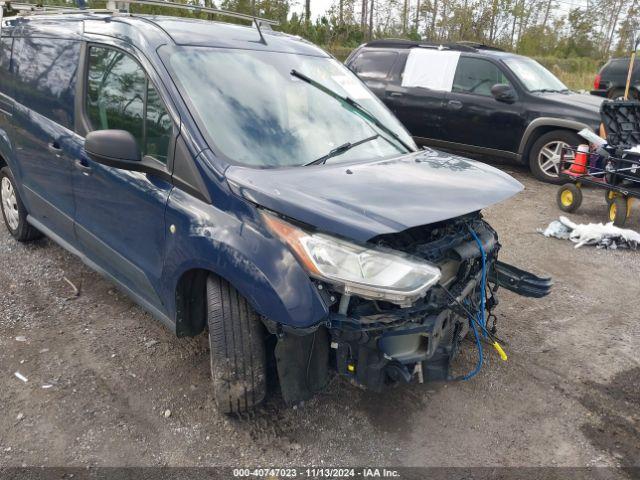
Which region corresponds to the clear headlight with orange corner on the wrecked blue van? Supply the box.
[263,213,440,306]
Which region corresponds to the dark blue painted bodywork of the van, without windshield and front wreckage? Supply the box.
[0,14,520,327]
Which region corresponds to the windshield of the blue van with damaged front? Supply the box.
[167,47,416,167]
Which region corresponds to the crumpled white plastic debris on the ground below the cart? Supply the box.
[539,217,640,250]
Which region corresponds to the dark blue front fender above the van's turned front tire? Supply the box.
[163,189,329,328]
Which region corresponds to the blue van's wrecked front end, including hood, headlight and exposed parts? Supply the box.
[227,150,552,403]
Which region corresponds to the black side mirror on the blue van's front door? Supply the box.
[84,130,142,171]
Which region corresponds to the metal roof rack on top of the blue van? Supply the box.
[0,0,280,26]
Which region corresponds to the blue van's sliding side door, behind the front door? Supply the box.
[12,36,80,244]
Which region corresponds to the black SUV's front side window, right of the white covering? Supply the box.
[452,57,510,97]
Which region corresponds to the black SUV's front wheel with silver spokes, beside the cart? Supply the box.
[529,130,583,184]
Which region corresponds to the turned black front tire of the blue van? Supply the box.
[207,275,267,414]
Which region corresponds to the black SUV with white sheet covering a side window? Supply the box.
[345,40,602,183]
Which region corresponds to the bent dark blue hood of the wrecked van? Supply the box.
[225,149,523,242]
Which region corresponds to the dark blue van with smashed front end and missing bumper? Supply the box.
[0,6,550,413]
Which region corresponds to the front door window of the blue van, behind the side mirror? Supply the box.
[86,47,172,163]
